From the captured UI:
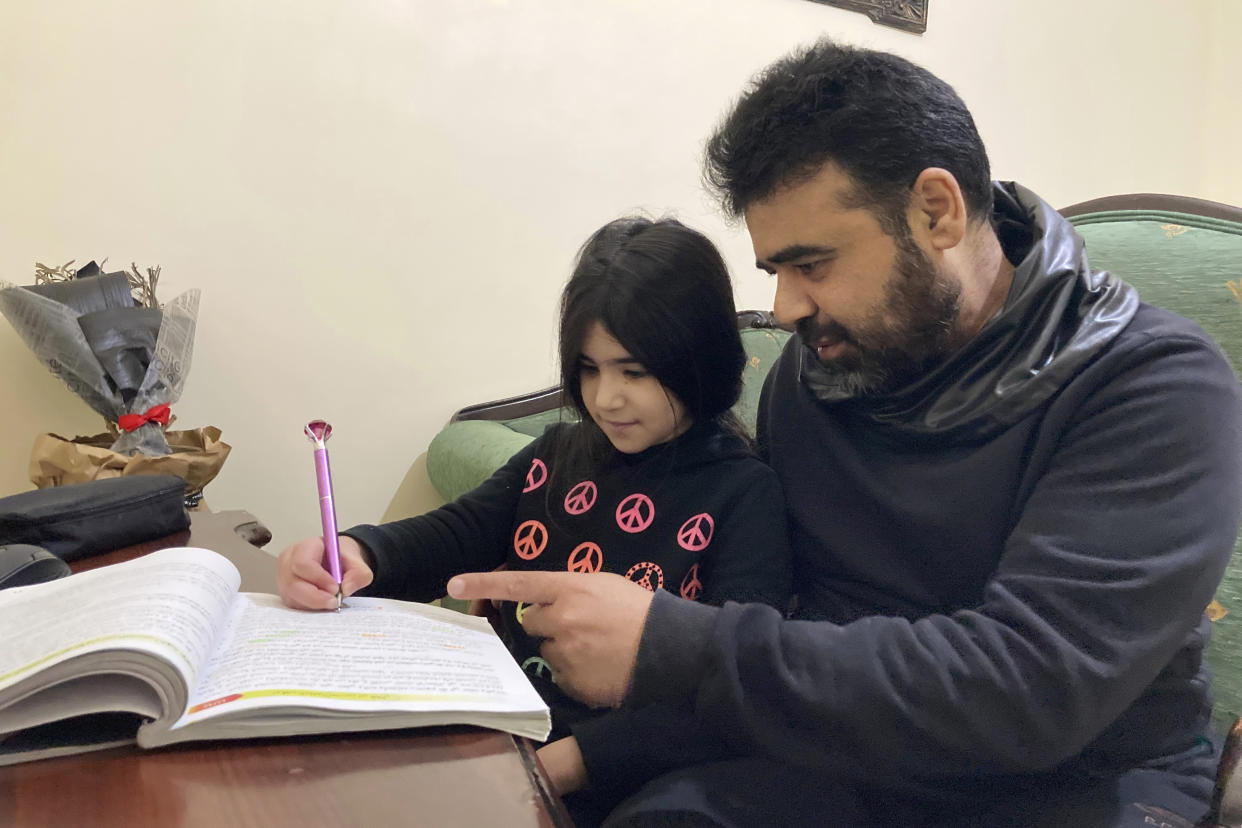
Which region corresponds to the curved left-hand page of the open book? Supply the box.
[0,547,241,695]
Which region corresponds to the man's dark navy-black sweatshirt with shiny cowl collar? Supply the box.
[627,185,1242,802]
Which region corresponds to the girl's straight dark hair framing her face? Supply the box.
[558,217,746,481]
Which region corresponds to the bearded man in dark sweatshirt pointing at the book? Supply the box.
[450,41,1242,826]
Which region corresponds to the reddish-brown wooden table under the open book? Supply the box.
[0,513,571,828]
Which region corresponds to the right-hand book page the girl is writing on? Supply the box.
[173,593,545,729]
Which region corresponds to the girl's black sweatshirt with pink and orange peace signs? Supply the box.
[344,423,790,790]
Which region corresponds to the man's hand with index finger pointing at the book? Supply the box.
[448,572,655,708]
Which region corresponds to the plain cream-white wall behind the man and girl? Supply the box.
[0,0,1242,549]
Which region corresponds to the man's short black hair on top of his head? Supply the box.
[703,38,992,235]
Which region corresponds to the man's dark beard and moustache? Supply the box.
[797,233,961,397]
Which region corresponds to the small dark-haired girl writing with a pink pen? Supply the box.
[278,218,790,822]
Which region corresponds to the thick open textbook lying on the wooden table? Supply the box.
[0,549,550,765]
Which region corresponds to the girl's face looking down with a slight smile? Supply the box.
[578,322,691,454]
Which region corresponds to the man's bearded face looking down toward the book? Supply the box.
[745,164,961,395]
